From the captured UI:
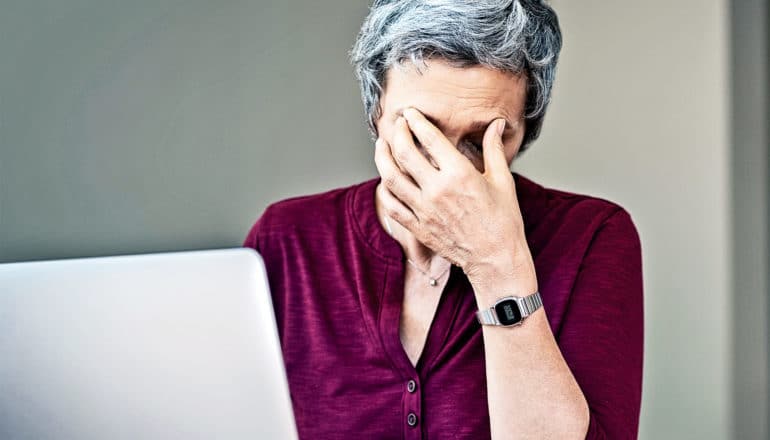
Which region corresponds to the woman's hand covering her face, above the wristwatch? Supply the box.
[375,108,534,298]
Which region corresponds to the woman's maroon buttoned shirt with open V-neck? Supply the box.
[244,173,643,440]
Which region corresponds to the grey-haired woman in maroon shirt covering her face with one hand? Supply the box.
[244,0,643,439]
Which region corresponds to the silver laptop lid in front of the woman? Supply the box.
[0,248,297,440]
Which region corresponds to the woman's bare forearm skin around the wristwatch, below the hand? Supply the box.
[468,262,589,440]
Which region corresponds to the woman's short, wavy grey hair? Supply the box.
[350,0,562,153]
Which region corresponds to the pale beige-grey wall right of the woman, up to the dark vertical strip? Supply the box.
[518,0,733,440]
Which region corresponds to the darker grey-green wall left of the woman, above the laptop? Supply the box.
[0,0,375,261]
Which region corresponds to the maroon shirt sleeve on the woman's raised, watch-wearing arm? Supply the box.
[557,208,644,440]
